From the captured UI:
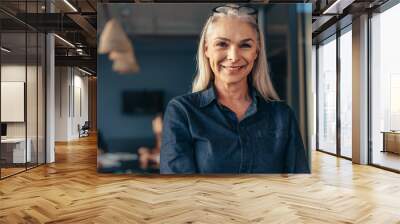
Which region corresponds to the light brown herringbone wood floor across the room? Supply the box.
[0,137,400,224]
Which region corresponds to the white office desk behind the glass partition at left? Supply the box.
[1,138,32,163]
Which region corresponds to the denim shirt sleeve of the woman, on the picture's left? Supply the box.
[160,100,197,174]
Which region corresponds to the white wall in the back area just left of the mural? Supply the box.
[55,67,89,141]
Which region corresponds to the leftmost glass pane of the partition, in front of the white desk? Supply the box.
[1,32,27,177]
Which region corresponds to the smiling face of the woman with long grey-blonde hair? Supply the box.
[205,16,258,84]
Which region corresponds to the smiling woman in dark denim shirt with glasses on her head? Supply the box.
[160,4,310,174]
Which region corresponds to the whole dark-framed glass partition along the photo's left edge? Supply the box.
[0,1,46,179]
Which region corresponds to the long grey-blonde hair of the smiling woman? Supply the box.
[192,4,279,101]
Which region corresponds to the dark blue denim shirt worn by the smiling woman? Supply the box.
[160,86,310,174]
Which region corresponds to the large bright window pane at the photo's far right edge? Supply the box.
[371,4,400,170]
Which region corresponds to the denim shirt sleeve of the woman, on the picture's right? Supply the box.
[286,109,310,173]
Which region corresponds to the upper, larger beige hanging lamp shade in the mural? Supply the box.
[98,19,133,54]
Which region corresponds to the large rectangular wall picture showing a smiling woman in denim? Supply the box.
[97,3,312,174]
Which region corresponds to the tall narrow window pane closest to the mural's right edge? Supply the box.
[318,38,336,156]
